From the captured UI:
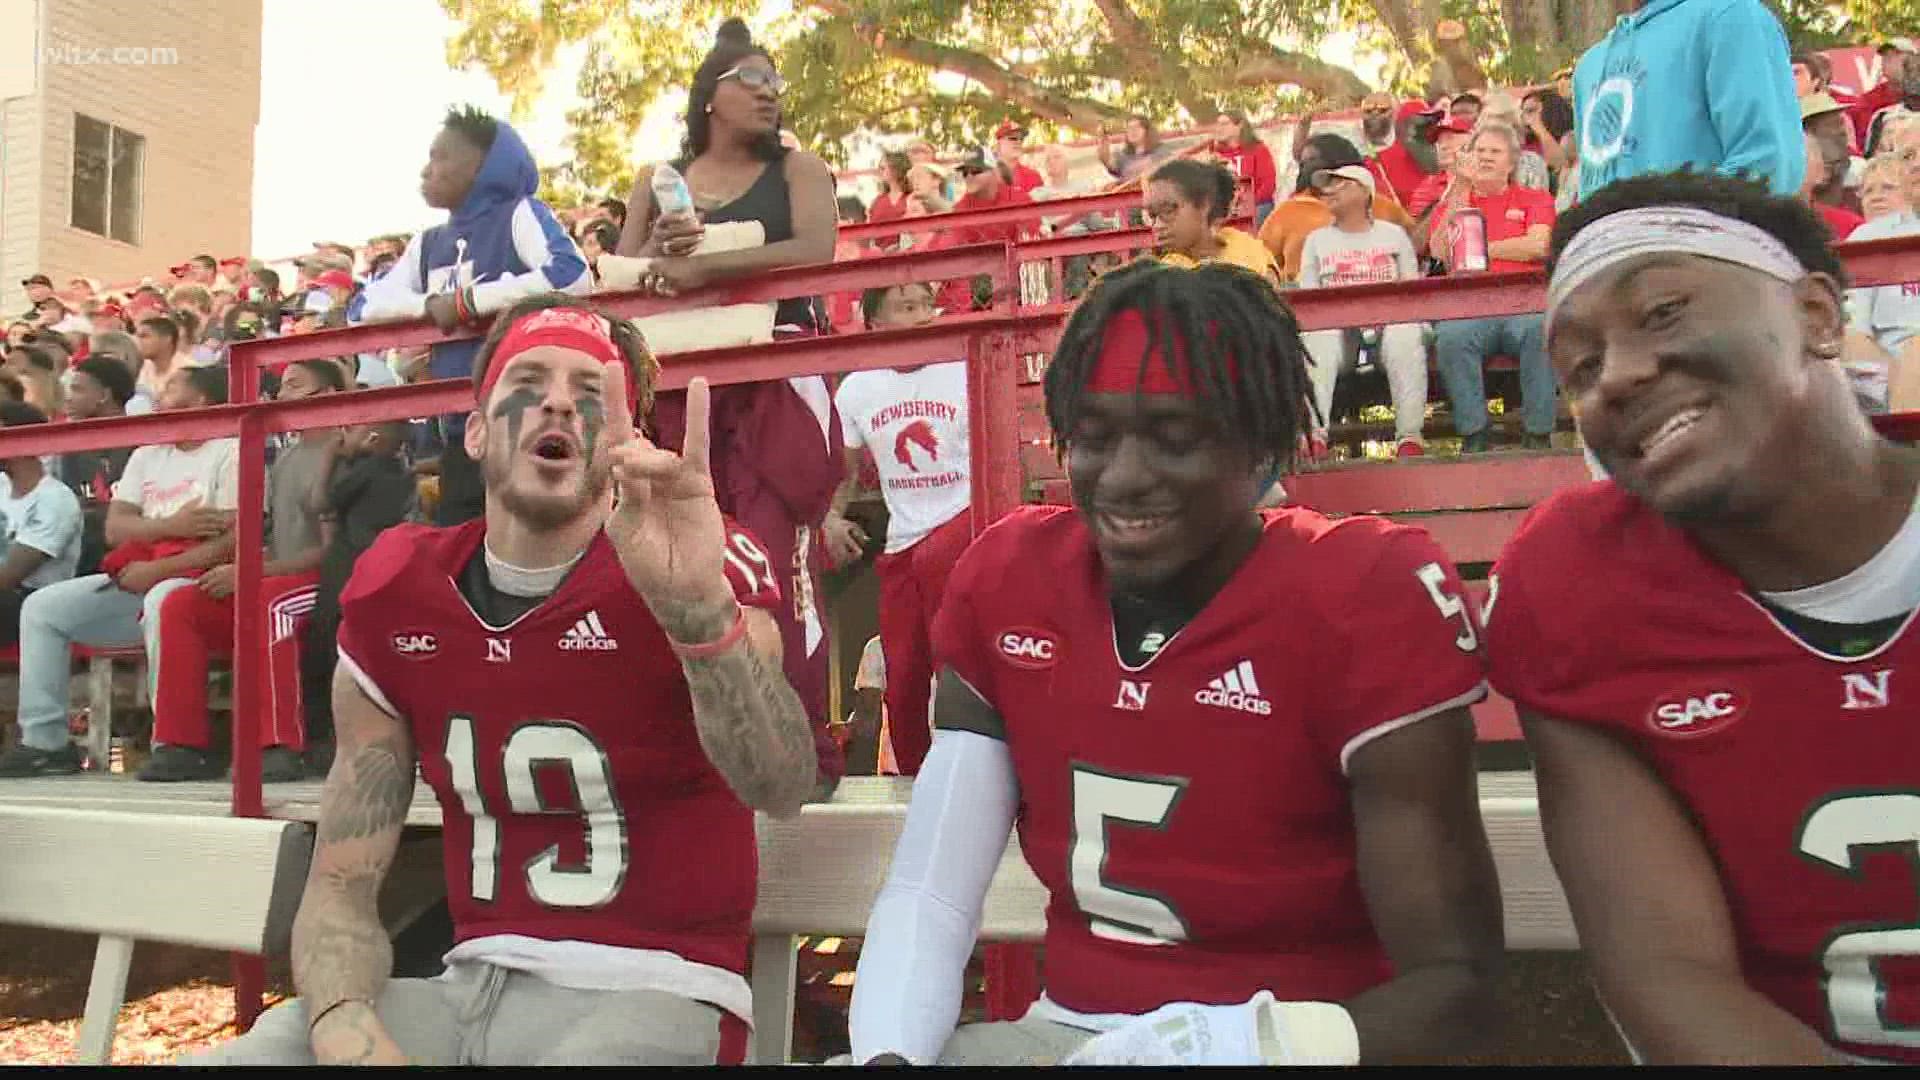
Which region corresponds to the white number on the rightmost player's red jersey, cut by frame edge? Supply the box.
[1799,792,1920,1047]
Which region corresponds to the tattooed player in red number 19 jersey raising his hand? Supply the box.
[200,294,816,1065]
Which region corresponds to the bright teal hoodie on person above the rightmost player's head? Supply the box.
[1572,0,1807,198]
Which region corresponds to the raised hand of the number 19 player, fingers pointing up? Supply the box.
[607,379,733,614]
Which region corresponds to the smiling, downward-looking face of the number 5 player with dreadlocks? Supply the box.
[1068,386,1258,592]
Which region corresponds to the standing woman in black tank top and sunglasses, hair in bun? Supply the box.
[620,19,835,331]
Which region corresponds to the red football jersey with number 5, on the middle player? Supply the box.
[933,507,1486,1013]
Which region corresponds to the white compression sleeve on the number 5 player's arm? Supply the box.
[849,730,1020,1065]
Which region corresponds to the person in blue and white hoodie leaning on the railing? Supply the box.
[359,108,593,525]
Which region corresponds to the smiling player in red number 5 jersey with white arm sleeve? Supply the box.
[851,263,1501,1065]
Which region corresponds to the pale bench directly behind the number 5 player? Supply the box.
[751,773,1578,1065]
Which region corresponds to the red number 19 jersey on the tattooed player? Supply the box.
[340,521,780,972]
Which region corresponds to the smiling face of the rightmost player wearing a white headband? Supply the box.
[1548,251,1841,521]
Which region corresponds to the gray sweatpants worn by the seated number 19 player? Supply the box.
[177,965,739,1065]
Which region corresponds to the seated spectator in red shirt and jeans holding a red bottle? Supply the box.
[1428,121,1555,454]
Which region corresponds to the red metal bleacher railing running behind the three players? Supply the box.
[0,228,1920,1024]
